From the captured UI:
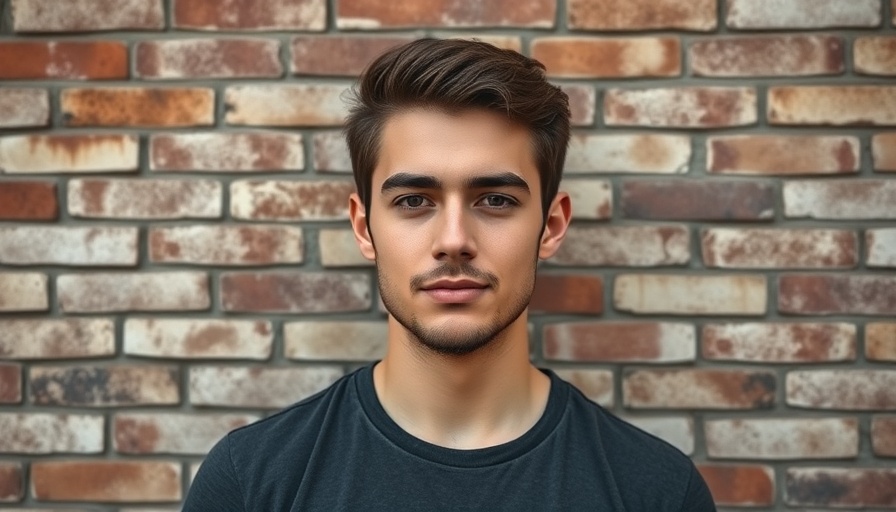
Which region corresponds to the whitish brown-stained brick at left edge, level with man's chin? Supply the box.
[0,318,115,358]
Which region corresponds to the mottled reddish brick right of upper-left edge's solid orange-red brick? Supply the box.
[135,39,283,80]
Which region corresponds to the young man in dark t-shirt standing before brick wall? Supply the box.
[184,39,715,512]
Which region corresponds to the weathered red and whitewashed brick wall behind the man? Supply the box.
[0,0,896,511]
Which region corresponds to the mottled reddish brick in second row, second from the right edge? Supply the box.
[688,35,844,77]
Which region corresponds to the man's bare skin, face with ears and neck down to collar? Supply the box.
[349,109,570,448]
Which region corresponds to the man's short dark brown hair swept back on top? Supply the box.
[344,38,570,215]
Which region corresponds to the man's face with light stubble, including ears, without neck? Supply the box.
[350,109,569,354]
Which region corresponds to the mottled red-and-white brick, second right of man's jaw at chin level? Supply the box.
[701,322,857,364]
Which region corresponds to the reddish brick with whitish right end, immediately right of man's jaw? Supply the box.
[542,322,697,363]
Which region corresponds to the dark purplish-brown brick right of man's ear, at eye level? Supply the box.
[621,180,775,221]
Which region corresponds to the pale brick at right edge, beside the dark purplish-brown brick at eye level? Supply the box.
[783,179,896,220]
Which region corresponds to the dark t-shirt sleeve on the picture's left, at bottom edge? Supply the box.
[181,436,245,512]
